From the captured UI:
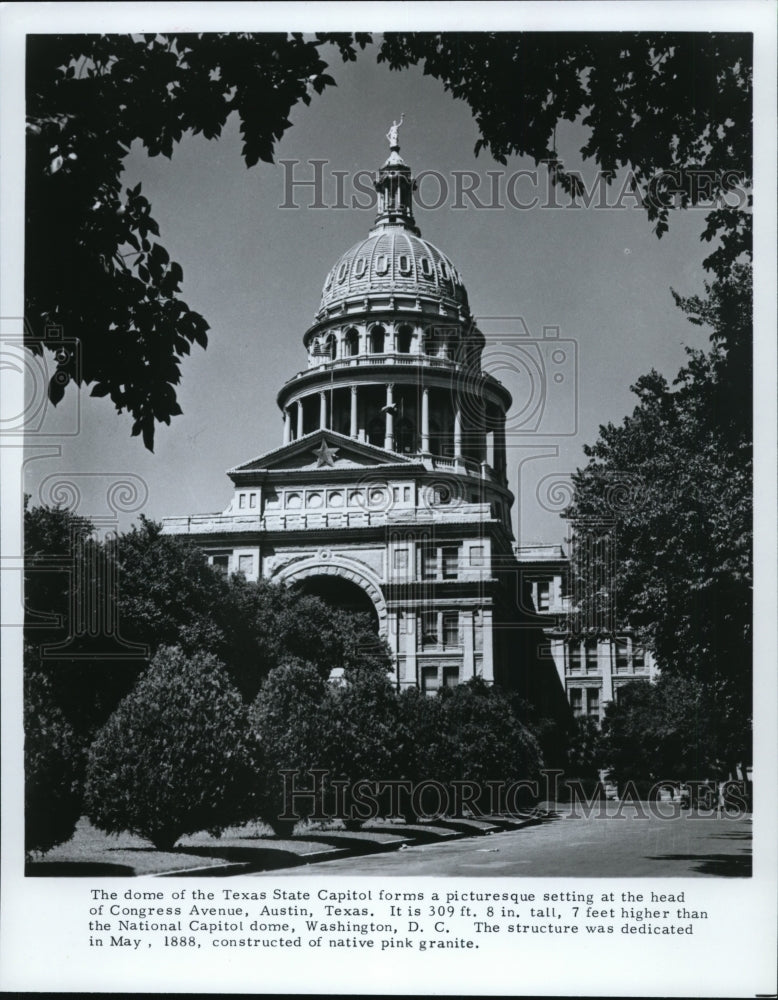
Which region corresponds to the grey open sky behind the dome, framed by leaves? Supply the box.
[26,33,710,544]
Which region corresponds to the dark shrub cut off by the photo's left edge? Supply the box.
[24,671,83,852]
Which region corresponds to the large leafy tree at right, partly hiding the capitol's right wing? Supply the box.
[566,268,752,769]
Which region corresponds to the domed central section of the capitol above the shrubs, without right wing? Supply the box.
[163,129,640,718]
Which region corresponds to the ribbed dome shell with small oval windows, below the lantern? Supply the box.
[320,224,468,311]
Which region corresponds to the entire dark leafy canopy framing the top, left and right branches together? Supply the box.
[25,32,752,448]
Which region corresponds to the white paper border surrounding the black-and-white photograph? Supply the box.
[0,0,778,996]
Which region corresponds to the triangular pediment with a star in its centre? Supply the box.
[228,430,418,477]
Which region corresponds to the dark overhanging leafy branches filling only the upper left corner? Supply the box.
[25,33,369,449]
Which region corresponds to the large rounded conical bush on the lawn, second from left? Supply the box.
[85,647,256,851]
